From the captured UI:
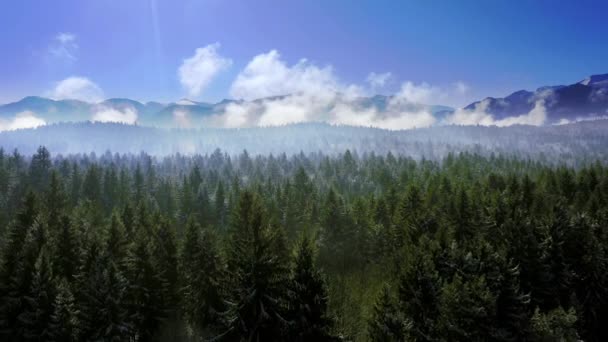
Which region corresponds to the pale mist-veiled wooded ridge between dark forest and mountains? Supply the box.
[0,120,608,167]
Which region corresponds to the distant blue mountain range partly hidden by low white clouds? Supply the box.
[0,74,608,127]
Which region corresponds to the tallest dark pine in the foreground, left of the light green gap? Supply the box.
[224,190,288,341]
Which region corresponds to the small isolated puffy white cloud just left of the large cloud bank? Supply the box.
[178,43,232,96]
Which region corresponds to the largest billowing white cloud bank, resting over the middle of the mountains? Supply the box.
[203,50,439,129]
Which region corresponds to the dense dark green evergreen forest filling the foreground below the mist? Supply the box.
[0,147,608,341]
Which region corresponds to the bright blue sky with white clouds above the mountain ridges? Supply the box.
[0,0,608,107]
